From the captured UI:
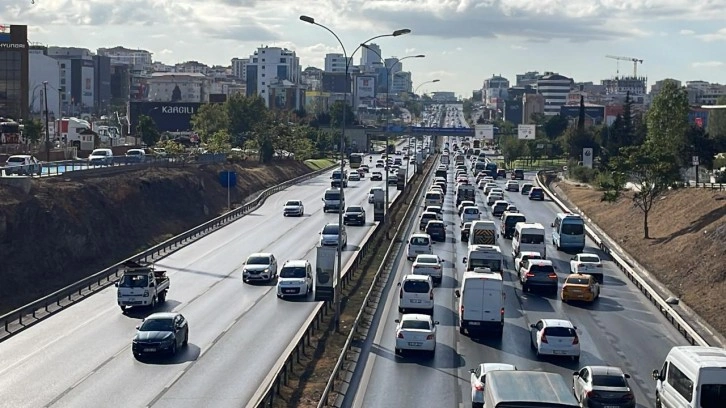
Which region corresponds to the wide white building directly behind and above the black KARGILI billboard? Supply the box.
[148,72,210,103]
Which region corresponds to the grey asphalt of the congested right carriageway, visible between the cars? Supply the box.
[343,131,687,408]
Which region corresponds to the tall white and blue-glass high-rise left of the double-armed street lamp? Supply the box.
[245,46,301,107]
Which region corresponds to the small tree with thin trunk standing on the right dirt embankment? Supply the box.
[603,144,679,239]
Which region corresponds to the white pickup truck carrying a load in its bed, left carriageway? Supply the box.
[116,261,170,313]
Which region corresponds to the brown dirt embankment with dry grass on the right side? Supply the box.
[557,183,726,335]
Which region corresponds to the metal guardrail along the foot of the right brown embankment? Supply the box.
[535,172,709,346]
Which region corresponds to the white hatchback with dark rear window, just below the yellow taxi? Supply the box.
[529,319,580,362]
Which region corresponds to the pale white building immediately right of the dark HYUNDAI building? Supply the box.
[28,49,61,120]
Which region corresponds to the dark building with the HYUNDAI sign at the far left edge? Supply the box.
[0,24,30,119]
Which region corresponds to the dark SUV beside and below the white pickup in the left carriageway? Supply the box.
[131,312,189,359]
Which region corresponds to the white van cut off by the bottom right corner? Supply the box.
[653,346,726,408]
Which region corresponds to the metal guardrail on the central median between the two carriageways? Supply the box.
[246,156,432,408]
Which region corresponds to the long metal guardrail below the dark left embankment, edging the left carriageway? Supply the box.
[0,164,338,341]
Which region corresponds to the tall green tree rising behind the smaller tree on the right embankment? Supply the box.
[647,80,690,165]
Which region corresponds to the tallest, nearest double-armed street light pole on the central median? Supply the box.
[300,15,411,331]
